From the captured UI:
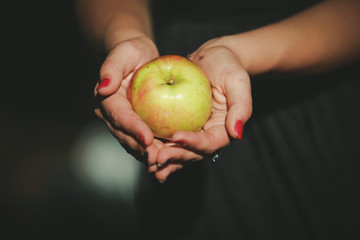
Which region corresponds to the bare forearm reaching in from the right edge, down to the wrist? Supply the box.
[227,0,360,74]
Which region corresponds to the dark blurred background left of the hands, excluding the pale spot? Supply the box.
[0,0,141,239]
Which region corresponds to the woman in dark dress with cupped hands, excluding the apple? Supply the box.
[78,0,360,239]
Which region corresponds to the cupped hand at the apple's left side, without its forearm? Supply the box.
[94,37,159,165]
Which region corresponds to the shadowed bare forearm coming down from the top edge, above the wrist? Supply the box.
[77,0,152,50]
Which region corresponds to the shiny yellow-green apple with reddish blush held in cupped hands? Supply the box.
[127,55,212,139]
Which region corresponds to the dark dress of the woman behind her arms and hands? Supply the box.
[137,0,360,239]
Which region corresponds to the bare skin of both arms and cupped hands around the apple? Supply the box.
[78,0,360,182]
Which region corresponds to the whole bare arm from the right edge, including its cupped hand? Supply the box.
[155,0,360,180]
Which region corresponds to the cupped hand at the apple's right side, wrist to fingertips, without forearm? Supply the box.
[155,39,252,182]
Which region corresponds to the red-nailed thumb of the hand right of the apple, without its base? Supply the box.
[225,71,252,139]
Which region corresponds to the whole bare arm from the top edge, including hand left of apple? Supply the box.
[77,0,159,166]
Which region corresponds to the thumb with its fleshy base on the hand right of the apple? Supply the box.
[194,47,252,139]
